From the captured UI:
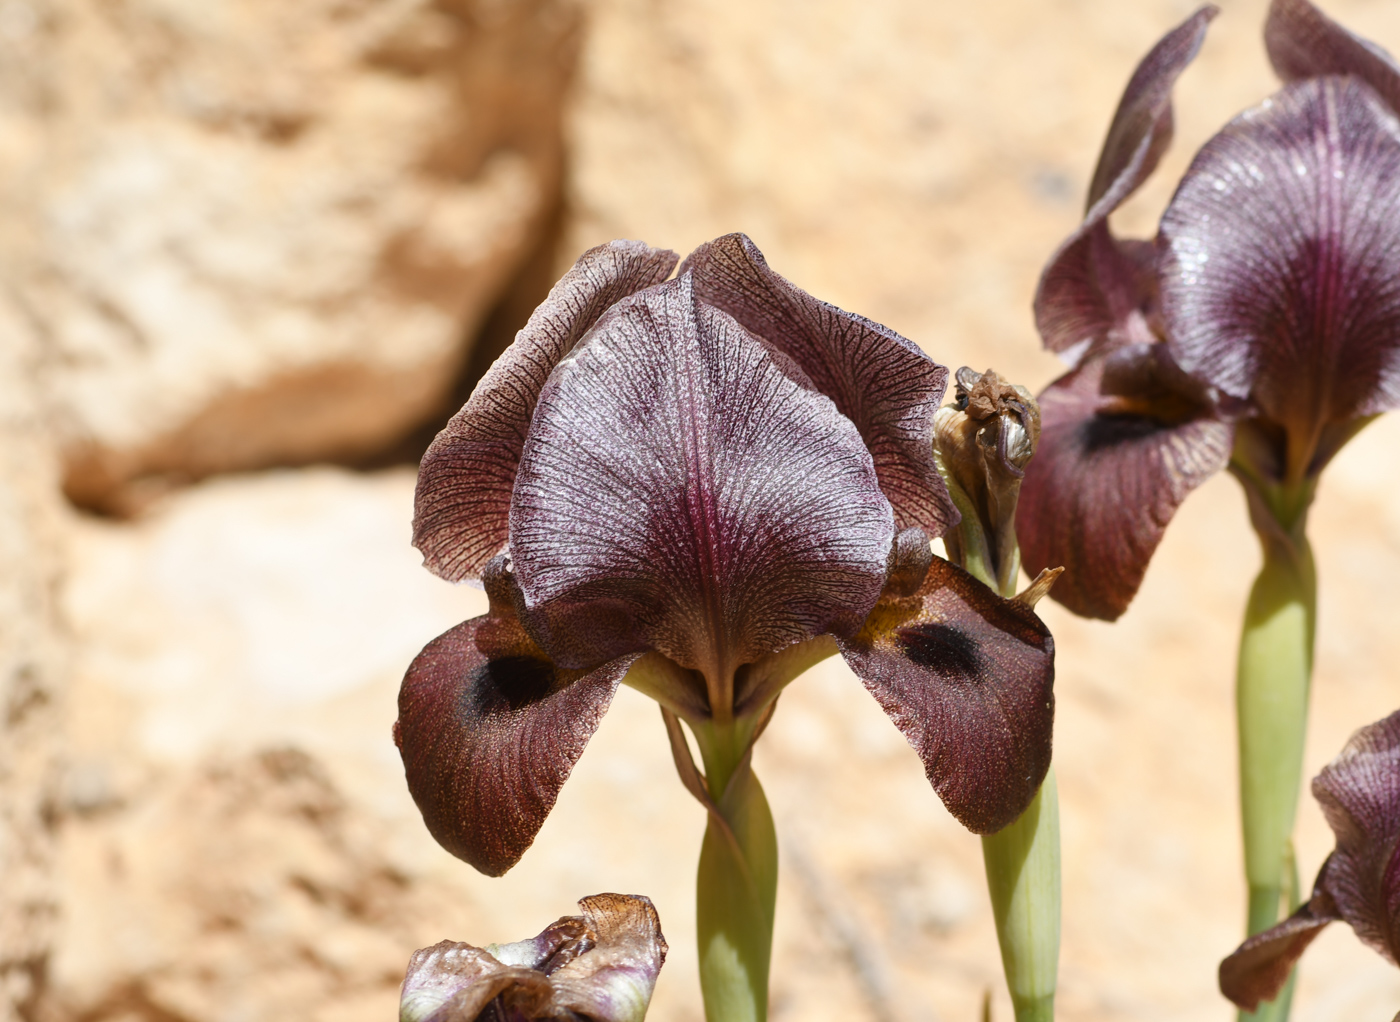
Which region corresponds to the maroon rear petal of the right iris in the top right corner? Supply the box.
[1264,0,1400,112]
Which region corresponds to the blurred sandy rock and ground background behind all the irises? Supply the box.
[8,0,1400,1022]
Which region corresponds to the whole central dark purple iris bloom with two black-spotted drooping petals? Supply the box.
[395,234,1053,875]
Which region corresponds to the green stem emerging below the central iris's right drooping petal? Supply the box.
[981,766,1060,1022]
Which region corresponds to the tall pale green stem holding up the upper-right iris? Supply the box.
[1235,472,1317,1022]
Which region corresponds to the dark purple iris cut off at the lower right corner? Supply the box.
[1219,713,1400,1011]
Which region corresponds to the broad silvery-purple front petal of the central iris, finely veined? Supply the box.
[511,274,895,679]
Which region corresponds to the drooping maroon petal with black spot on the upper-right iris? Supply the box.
[1016,344,1232,620]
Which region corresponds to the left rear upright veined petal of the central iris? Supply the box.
[413,233,676,582]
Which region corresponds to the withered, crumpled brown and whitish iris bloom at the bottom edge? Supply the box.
[399,895,666,1022]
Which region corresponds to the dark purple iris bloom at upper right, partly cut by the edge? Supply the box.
[1016,0,1400,620]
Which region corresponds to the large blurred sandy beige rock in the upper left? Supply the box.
[0,0,578,505]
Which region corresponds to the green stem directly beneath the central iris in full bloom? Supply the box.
[693,718,778,1022]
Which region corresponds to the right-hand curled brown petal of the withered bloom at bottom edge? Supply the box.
[550,895,666,1022]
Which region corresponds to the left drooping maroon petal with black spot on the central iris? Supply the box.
[393,615,636,876]
